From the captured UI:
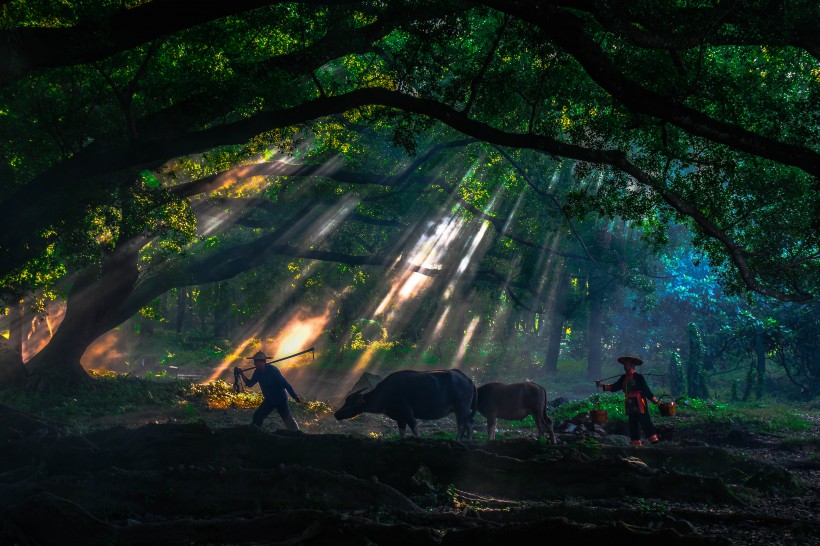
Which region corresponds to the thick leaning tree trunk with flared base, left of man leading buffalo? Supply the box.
[27,239,144,388]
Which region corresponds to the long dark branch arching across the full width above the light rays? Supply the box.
[0,88,810,301]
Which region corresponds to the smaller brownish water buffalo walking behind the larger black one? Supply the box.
[478,382,555,444]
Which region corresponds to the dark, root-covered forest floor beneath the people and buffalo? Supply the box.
[0,368,820,546]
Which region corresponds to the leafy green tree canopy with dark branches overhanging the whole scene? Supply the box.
[0,0,820,382]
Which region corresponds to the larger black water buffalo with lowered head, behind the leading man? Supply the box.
[333,370,477,440]
